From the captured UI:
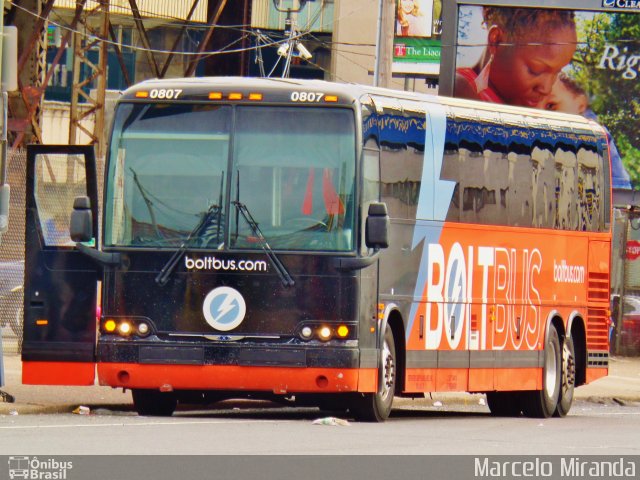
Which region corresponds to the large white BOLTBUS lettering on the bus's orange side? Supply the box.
[425,242,542,350]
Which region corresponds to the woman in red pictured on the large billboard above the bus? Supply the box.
[455,7,577,107]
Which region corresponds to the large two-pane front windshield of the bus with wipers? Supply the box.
[105,103,356,251]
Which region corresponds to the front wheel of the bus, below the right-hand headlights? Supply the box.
[350,325,397,422]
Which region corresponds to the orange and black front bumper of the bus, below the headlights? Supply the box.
[97,342,377,395]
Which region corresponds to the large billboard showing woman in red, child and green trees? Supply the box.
[440,0,640,189]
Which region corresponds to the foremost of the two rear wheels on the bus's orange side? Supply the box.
[522,325,562,418]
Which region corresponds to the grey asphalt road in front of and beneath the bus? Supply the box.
[0,400,640,456]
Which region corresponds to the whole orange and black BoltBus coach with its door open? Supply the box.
[22,78,611,421]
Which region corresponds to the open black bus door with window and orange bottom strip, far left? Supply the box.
[22,145,100,385]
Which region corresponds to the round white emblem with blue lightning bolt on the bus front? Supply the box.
[202,287,247,332]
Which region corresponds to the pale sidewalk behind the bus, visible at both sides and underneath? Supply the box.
[0,354,640,415]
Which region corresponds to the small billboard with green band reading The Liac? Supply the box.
[392,0,442,75]
